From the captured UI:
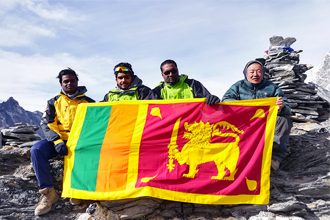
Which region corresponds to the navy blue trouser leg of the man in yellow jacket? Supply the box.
[31,139,58,189]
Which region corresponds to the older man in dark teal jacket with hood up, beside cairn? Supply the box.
[222,59,292,170]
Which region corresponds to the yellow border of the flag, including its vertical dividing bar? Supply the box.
[62,97,278,204]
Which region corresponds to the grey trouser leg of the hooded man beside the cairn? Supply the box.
[272,115,292,162]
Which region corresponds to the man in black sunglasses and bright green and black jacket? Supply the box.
[153,60,220,105]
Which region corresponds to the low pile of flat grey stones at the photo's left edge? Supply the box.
[0,123,41,148]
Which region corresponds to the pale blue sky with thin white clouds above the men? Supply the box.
[0,0,330,111]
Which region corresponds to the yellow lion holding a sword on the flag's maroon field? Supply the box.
[167,118,244,181]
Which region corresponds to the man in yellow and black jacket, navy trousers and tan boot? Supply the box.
[31,68,95,215]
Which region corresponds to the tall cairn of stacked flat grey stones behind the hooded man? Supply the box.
[265,36,329,122]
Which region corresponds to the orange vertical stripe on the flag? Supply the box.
[96,105,139,192]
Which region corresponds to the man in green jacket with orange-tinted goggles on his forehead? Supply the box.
[102,63,157,102]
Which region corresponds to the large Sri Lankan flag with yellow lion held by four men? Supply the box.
[62,98,278,204]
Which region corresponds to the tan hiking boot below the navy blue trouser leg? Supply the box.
[34,187,60,215]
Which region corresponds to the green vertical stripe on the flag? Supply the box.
[71,106,112,192]
